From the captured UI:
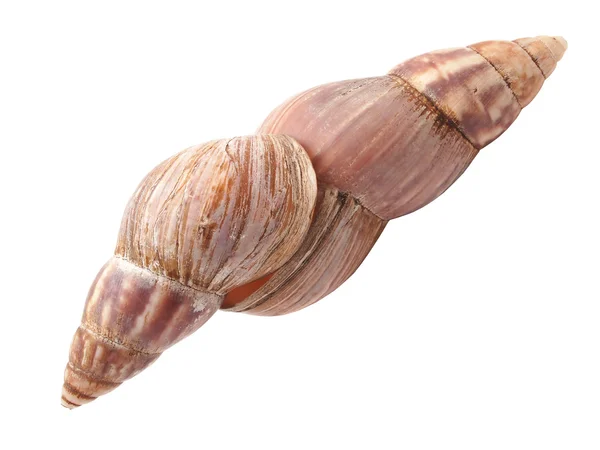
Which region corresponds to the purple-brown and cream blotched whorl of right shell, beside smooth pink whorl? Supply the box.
[390,48,521,149]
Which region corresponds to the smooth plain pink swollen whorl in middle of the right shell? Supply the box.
[259,76,477,220]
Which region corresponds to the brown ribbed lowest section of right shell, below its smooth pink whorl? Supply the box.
[226,187,387,316]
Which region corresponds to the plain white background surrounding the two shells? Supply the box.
[0,0,600,450]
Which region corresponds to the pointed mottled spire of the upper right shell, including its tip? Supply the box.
[389,36,566,150]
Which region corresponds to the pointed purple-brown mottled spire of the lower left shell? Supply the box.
[61,257,223,409]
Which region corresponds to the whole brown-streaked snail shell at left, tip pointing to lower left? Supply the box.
[62,135,317,408]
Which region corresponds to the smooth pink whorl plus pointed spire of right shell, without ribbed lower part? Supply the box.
[259,37,566,220]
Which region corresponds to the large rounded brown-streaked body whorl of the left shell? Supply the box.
[115,135,316,294]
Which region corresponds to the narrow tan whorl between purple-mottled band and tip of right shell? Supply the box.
[470,41,544,107]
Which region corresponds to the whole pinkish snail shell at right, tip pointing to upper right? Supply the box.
[223,36,567,315]
